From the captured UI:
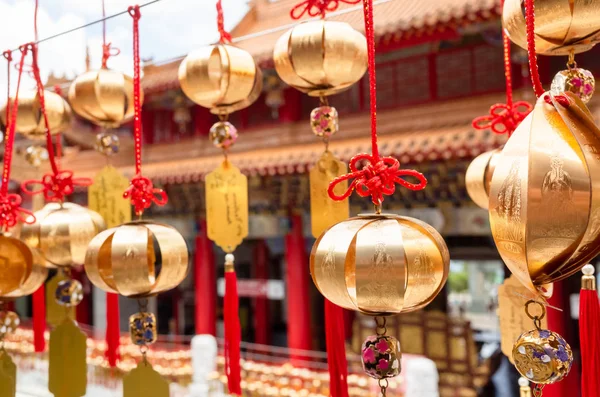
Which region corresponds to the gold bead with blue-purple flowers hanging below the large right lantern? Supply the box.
[512,329,573,384]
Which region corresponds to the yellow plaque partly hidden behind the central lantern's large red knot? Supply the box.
[310,151,350,238]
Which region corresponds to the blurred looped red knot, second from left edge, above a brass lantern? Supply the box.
[21,170,92,202]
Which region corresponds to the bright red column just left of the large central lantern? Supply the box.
[285,215,311,350]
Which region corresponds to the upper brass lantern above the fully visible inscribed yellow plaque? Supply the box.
[179,44,262,114]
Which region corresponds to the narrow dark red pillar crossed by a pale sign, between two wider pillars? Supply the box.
[254,240,271,345]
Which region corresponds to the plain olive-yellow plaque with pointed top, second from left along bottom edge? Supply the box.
[48,318,87,397]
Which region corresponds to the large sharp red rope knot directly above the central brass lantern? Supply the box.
[327,153,427,205]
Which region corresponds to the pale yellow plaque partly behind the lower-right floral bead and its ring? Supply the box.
[498,275,548,364]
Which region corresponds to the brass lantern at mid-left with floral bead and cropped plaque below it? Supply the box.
[85,221,188,297]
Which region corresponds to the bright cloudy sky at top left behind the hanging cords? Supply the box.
[0,0,248,93]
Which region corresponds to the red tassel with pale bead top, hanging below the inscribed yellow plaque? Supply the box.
[223,254,242,396]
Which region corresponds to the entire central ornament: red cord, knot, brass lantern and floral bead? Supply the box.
[310,0,450,396]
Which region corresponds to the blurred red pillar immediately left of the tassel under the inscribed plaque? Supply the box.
[194,221,217,336]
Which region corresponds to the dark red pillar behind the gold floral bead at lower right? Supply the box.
[544,281,581,397]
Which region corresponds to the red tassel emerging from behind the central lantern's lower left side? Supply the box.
[325,298,348,397]
